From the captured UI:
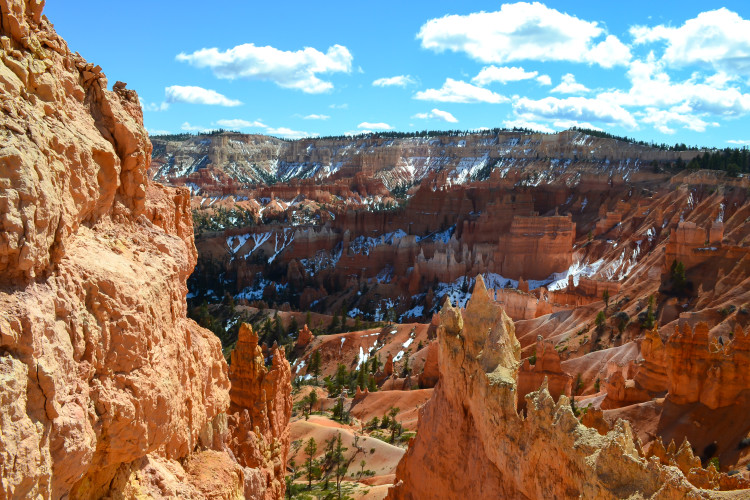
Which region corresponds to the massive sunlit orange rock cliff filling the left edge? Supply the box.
[0,0,288,499]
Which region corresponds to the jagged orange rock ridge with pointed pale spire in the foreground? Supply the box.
[388,278,748,499]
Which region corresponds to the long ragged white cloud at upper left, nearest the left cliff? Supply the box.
[177,43,352,94]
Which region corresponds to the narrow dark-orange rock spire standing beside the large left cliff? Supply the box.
[227,323,292,500]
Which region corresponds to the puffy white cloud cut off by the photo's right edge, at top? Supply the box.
[630,8,750,77]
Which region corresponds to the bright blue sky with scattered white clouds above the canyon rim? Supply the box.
[45,0,750,147]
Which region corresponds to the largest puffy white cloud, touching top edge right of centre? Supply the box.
[417,2,631,68]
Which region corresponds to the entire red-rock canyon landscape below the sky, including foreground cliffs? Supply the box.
[0,0,750,500]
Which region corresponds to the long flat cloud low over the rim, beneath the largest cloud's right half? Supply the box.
[513,97,638,129]
